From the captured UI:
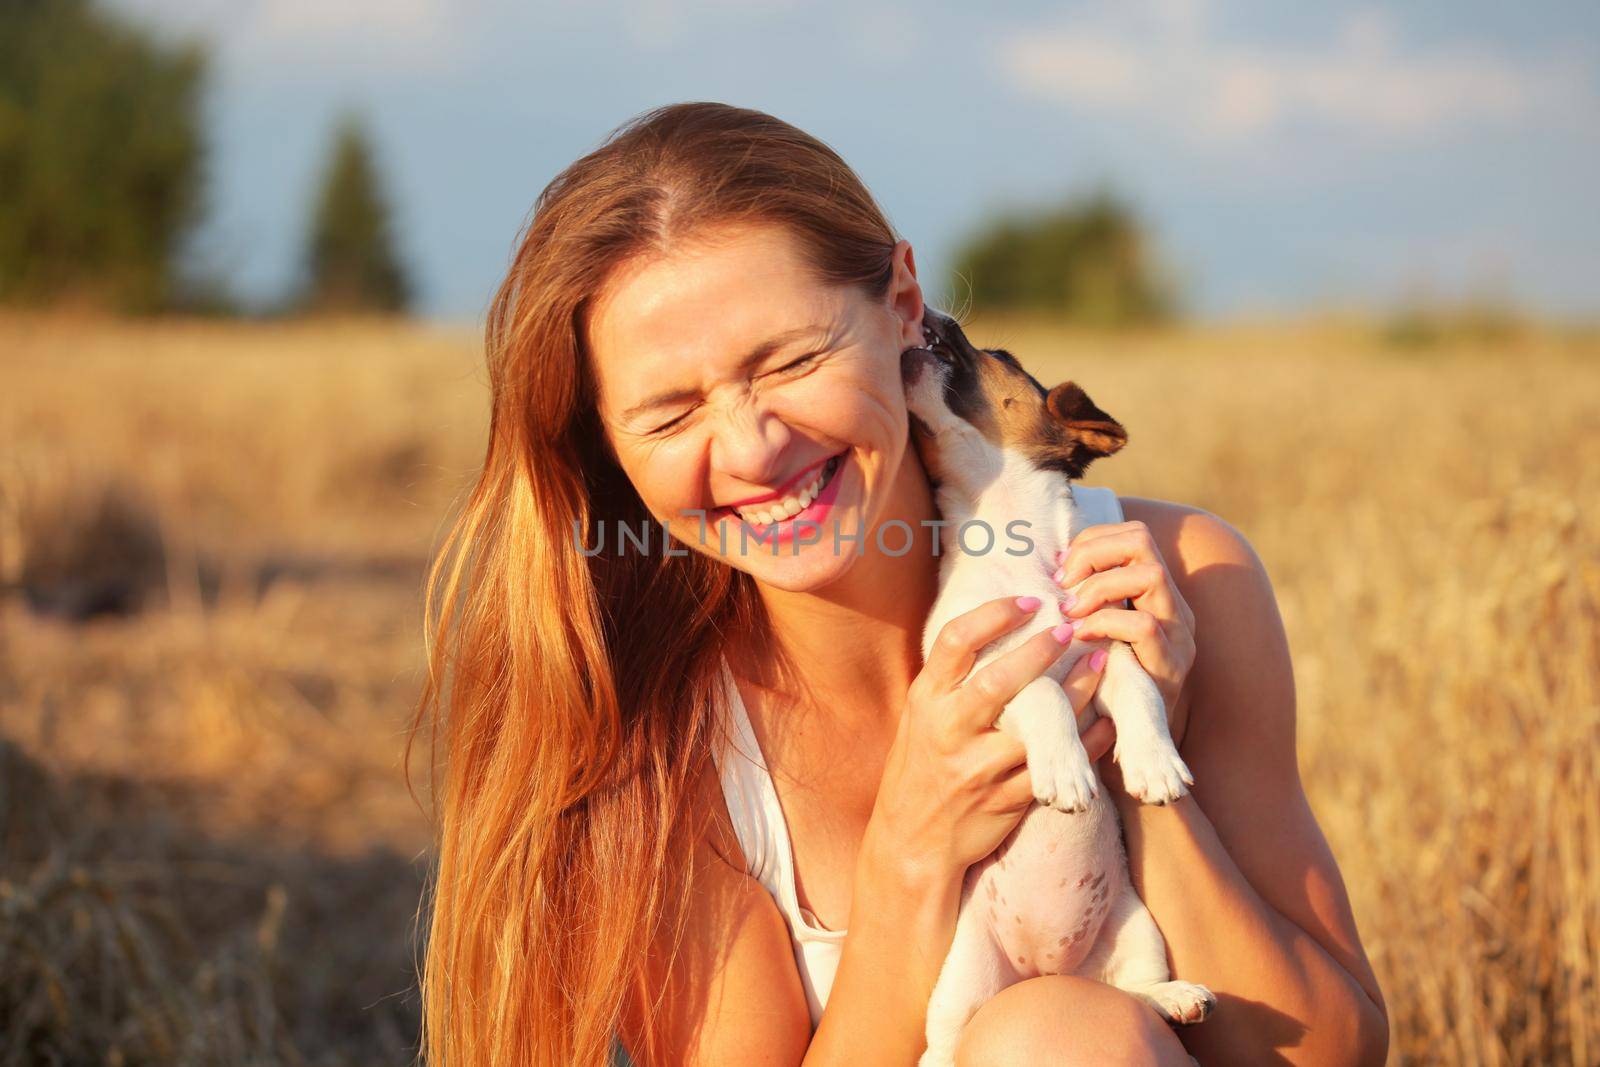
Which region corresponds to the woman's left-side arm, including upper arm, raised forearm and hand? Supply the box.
[624,597,1112,1067]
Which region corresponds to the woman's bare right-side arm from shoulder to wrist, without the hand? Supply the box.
[1107,501,1389,1065]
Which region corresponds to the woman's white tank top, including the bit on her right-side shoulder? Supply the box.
[712,485,1123,1030]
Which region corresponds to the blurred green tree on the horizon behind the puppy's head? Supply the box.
[954,190,1178,326]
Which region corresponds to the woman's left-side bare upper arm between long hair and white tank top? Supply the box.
[621,773,811,1067]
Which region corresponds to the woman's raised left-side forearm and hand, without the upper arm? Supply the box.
[805,607,1112,1067]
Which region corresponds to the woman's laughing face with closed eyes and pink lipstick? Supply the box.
[587,224,923,590]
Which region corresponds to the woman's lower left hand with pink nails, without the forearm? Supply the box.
[867,597,1114,878]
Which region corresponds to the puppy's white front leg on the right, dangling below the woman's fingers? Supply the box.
[1094,641,1195,805]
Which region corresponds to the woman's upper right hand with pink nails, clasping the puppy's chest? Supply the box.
[1054,522,1195,745]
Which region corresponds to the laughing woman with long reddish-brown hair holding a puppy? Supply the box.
[422,104,1387,1067]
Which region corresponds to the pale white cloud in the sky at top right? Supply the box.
[994,0,1600,141]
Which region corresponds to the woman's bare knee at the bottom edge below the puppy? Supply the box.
[955,976,1190,1067]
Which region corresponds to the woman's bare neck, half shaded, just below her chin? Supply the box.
[747,445,949,735]
